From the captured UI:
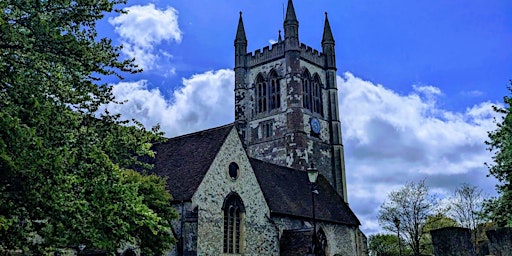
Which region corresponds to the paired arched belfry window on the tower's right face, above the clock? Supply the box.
[302,69,323,115]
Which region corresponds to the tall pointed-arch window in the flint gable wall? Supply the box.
[222,192,245,253]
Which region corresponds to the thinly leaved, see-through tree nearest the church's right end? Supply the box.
[379,180,438,256]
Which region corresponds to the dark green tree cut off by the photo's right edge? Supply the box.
[485,80,512,227]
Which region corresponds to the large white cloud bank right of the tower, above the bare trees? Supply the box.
[338,73,496,236]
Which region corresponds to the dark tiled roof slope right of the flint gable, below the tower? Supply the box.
[249,158,360,226]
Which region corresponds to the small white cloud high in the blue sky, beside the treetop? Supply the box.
[109,4,182,70]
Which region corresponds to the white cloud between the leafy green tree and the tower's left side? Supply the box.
[106,69,234,137]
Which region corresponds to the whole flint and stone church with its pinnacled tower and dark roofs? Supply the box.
[151,0,368,256]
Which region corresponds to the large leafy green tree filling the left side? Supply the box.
[0,0,176,255]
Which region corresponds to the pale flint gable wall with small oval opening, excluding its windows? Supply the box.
[192,129,279,255]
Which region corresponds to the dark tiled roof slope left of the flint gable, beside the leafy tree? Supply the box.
[151,124,233,201]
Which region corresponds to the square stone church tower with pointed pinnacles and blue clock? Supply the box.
[234,0,347,201]
